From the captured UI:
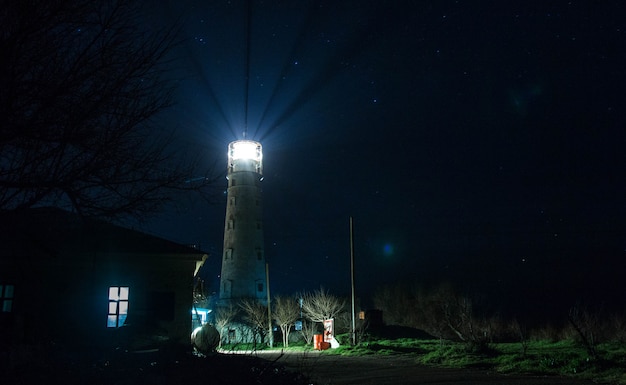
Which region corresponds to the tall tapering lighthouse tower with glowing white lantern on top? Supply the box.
[219,140,267,305]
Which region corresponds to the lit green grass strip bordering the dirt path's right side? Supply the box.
[316,338,626,384]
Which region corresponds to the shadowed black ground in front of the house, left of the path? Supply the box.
[0,351,310,385]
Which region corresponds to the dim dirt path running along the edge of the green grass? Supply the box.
[239,351,593,385]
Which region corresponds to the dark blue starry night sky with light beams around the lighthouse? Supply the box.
[144,0,626,316]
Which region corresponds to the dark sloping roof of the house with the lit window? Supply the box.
[0,207,207,260]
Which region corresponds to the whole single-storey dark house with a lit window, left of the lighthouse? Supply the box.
[0,208,207,350]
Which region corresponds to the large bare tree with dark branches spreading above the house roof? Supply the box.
[0,0,215,218]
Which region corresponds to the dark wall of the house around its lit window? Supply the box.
[0,250,196,349]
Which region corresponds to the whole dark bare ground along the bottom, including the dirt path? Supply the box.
[2,344,593,385]
